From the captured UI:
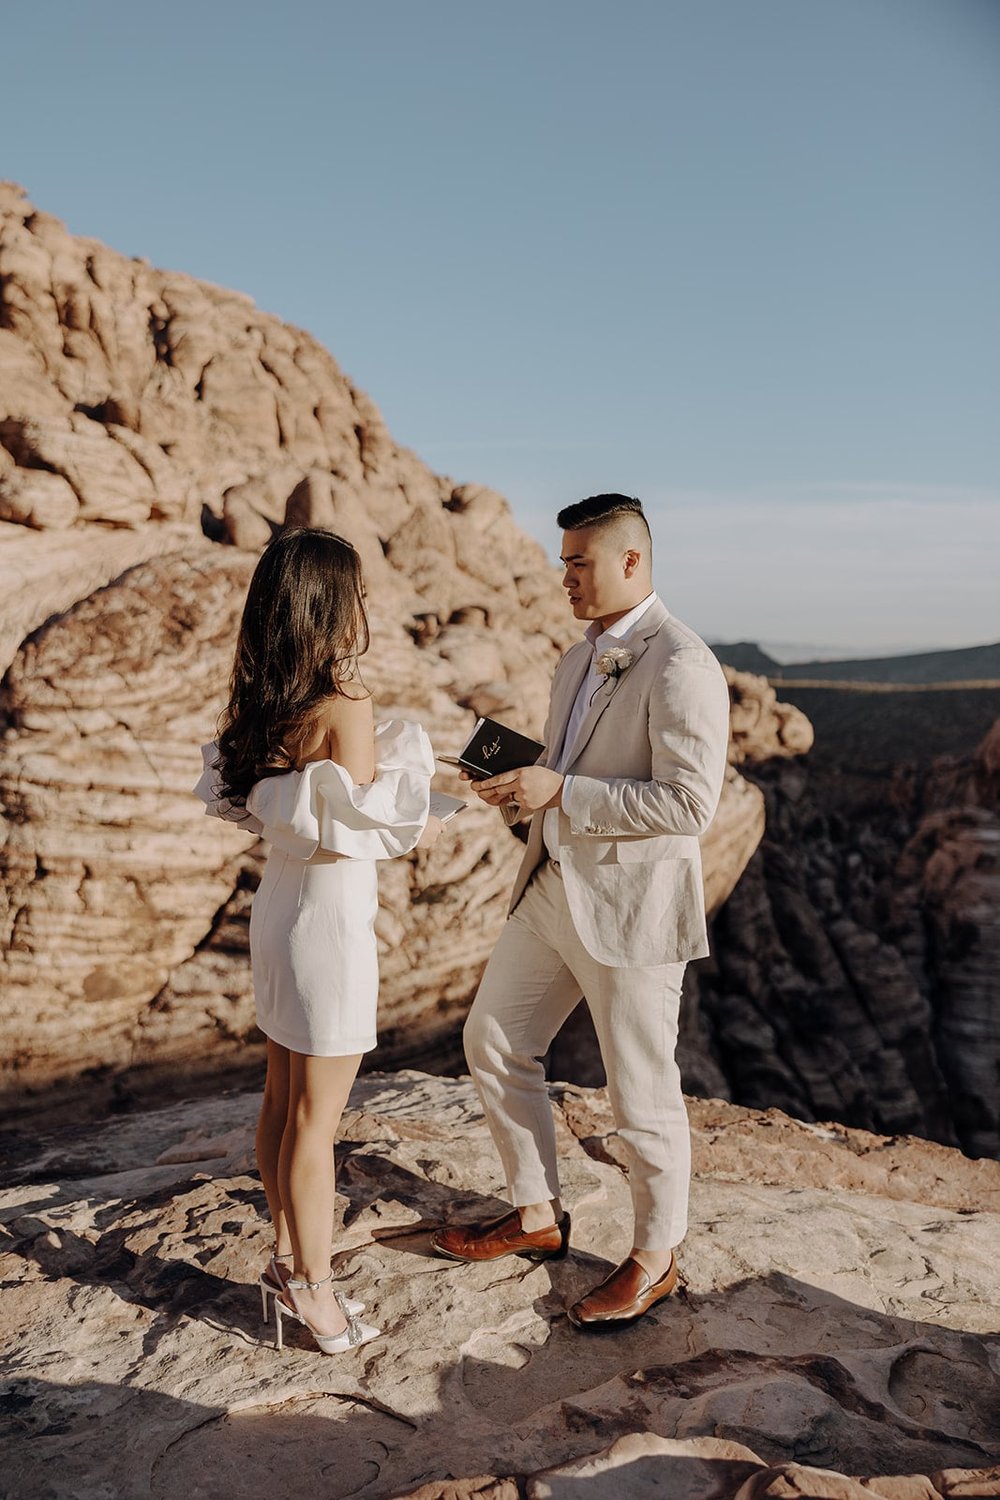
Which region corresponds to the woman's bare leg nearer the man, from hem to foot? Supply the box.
[277,1052,361,1334]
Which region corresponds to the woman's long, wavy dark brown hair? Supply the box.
[217,527,369,806]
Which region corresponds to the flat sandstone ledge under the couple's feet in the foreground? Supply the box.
[0,1074,1000,1500]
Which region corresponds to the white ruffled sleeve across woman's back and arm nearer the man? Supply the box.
[246,719,435,860]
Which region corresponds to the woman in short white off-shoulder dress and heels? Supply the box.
[195,528,442,1355]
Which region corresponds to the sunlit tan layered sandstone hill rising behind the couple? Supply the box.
[0,185,808,1110]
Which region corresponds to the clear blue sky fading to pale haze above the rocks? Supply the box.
[0,0,1000,653]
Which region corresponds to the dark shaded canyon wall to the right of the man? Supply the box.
[697,722,1000,1157]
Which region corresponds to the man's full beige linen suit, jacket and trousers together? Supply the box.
[465,600,729,1250]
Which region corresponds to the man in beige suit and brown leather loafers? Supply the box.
[433,495,729,1329]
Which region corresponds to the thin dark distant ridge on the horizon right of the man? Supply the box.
[712,641,1000,687]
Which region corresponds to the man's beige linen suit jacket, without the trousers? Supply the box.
[510,600,729,969]
